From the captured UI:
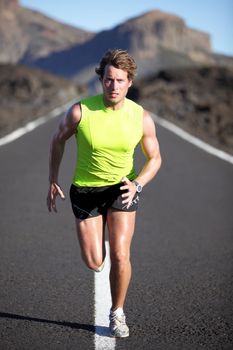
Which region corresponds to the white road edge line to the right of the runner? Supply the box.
[150,112,233,164]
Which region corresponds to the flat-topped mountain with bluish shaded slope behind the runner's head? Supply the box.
[22,10,233,85]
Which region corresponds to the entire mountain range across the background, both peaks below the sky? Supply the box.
[0,0,233,87]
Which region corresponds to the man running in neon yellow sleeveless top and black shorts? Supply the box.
[47,49,161,338]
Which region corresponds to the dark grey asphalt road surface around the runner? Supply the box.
[0,113,233,350]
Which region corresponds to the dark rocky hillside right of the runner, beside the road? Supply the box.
[127,67,233,154]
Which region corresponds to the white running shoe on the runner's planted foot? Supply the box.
[109,309,129,338]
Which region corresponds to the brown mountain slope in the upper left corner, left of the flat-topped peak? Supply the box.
[0,0,94,64]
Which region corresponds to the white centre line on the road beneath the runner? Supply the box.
[95,241,116,350]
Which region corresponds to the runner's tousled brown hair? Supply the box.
[95,49,137,81]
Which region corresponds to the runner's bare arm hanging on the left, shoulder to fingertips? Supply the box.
[47,104,81,212]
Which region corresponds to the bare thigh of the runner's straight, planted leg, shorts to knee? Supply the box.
[107,208,136,258]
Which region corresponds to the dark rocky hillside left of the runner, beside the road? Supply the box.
[0,64,83,137]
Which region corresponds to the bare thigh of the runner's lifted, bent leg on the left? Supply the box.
[76,215,106,262]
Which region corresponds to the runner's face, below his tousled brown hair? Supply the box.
[102,65,132,109]
